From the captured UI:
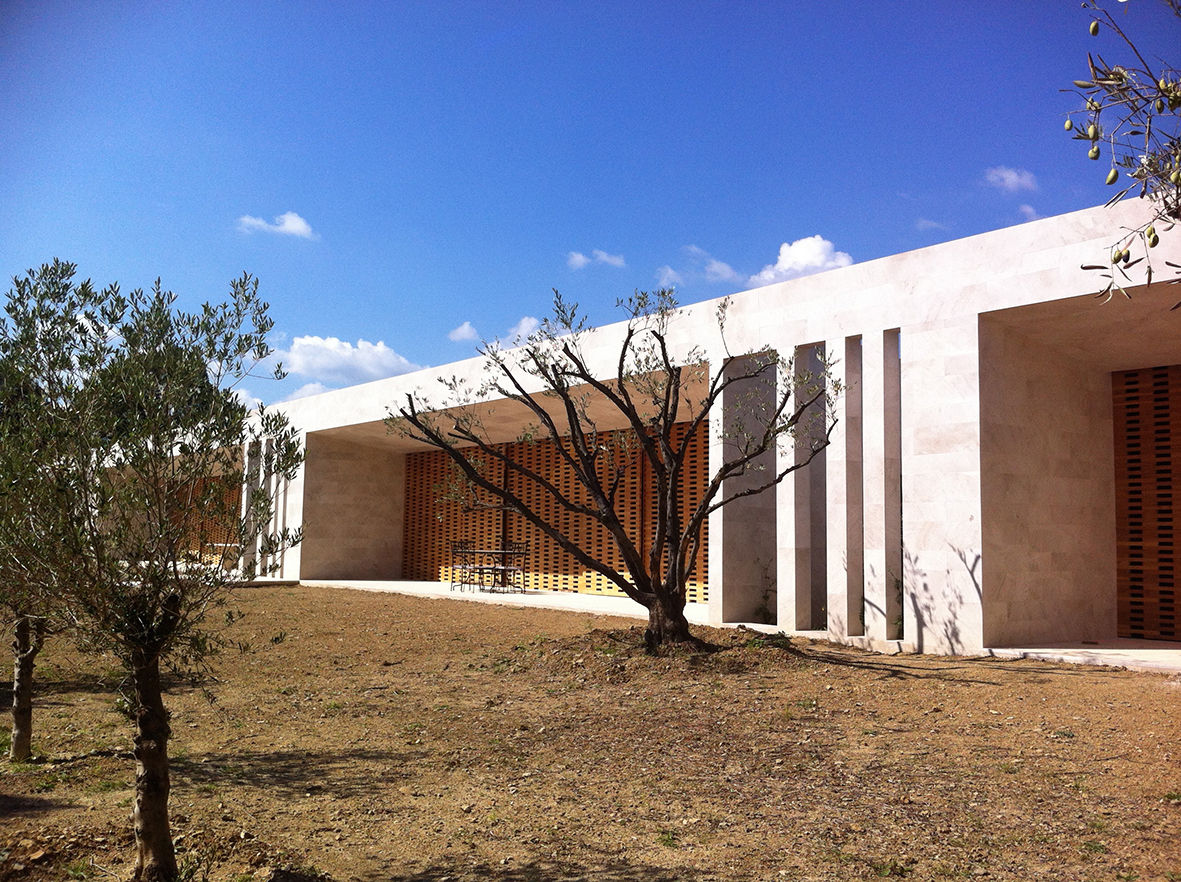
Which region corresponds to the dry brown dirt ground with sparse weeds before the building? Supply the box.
[0,588,1181,882]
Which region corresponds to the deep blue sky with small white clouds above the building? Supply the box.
[0,0,1181,400]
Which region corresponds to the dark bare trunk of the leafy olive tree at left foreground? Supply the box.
[132,654,176,882]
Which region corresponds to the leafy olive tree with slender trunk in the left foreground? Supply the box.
[0,262,301,882]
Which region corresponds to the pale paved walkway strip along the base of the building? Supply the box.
[270,580,1181,673]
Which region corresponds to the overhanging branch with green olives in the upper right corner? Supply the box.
[1065,0,1181,296]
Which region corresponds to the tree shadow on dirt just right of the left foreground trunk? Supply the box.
[171,747,430,798]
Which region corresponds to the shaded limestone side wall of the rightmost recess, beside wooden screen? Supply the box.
[980,321,1116,646]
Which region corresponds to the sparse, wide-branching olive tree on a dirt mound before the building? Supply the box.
[386,290,839,647]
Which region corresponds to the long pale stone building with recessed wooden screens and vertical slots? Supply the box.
[258,201,1181,653]
